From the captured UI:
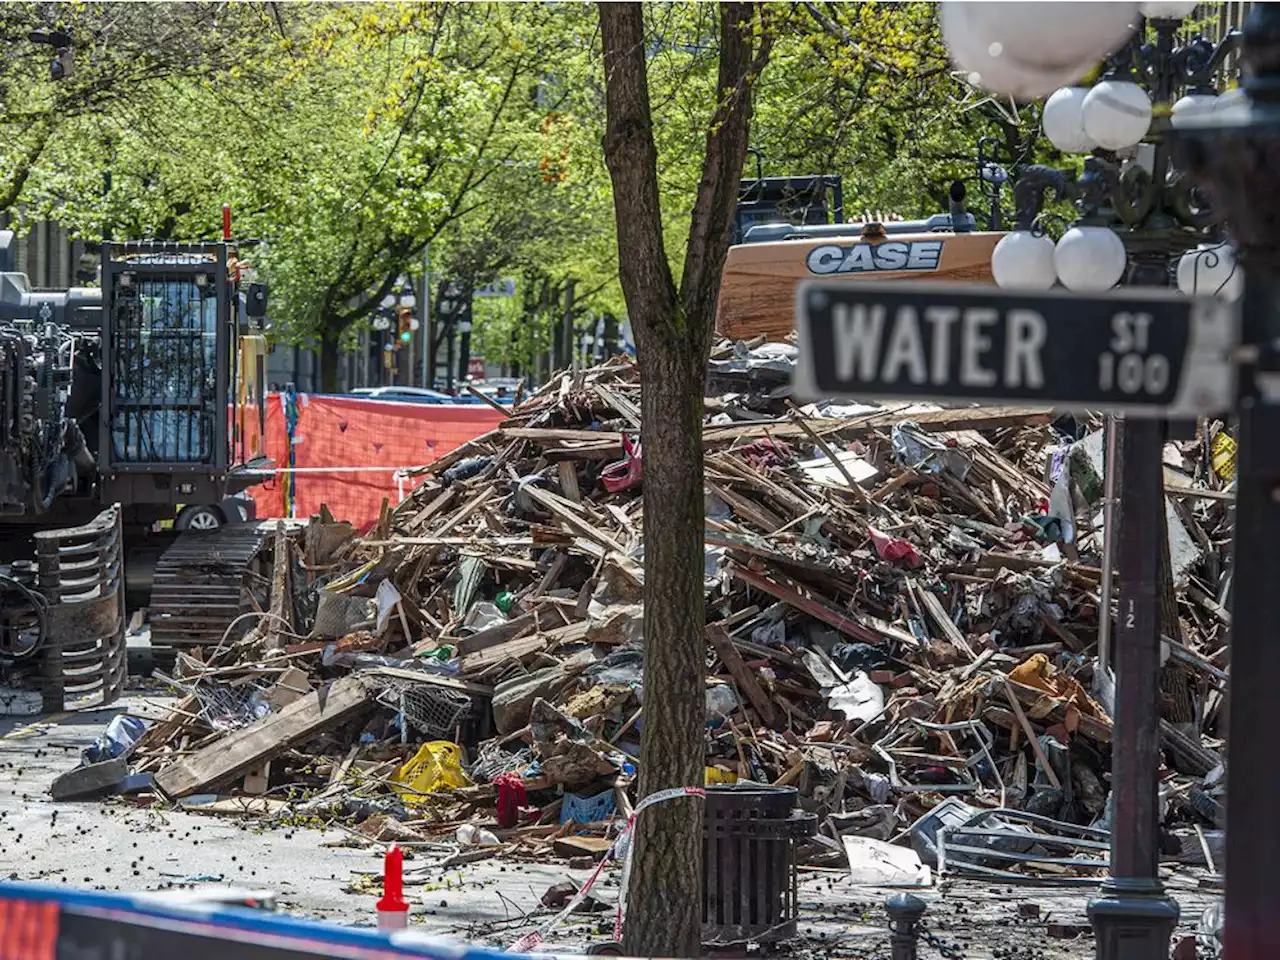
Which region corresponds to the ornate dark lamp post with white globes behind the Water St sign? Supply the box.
[943,3,1239,960]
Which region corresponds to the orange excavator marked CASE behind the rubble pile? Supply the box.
[716,175,1005,340]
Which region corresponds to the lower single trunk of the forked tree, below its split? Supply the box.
[625,340,707,956]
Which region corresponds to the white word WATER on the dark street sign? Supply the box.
[831,303,1048,389]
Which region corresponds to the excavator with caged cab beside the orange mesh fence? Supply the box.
[0,232,271,713]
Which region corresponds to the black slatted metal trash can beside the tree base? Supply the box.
[703,783,818,945]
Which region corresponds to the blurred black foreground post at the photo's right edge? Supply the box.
[1174,4,1280,960]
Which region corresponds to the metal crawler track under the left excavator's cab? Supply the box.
[150,522,274,648]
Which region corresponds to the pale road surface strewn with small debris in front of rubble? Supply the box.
[0,692,1213,960]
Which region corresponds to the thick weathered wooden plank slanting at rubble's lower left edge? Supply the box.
[155,677,371,799]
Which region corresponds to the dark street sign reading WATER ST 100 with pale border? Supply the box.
[795,280,1239,416]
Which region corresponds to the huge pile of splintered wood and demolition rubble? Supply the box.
[77,344,1231,896]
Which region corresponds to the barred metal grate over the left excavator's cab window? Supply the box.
[110,275,218,463]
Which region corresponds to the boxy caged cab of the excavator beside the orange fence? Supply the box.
[99,242,265,506]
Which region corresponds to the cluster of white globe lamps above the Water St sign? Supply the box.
[942,3,1248,300]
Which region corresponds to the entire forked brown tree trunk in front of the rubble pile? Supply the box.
[599,3,769,957]
